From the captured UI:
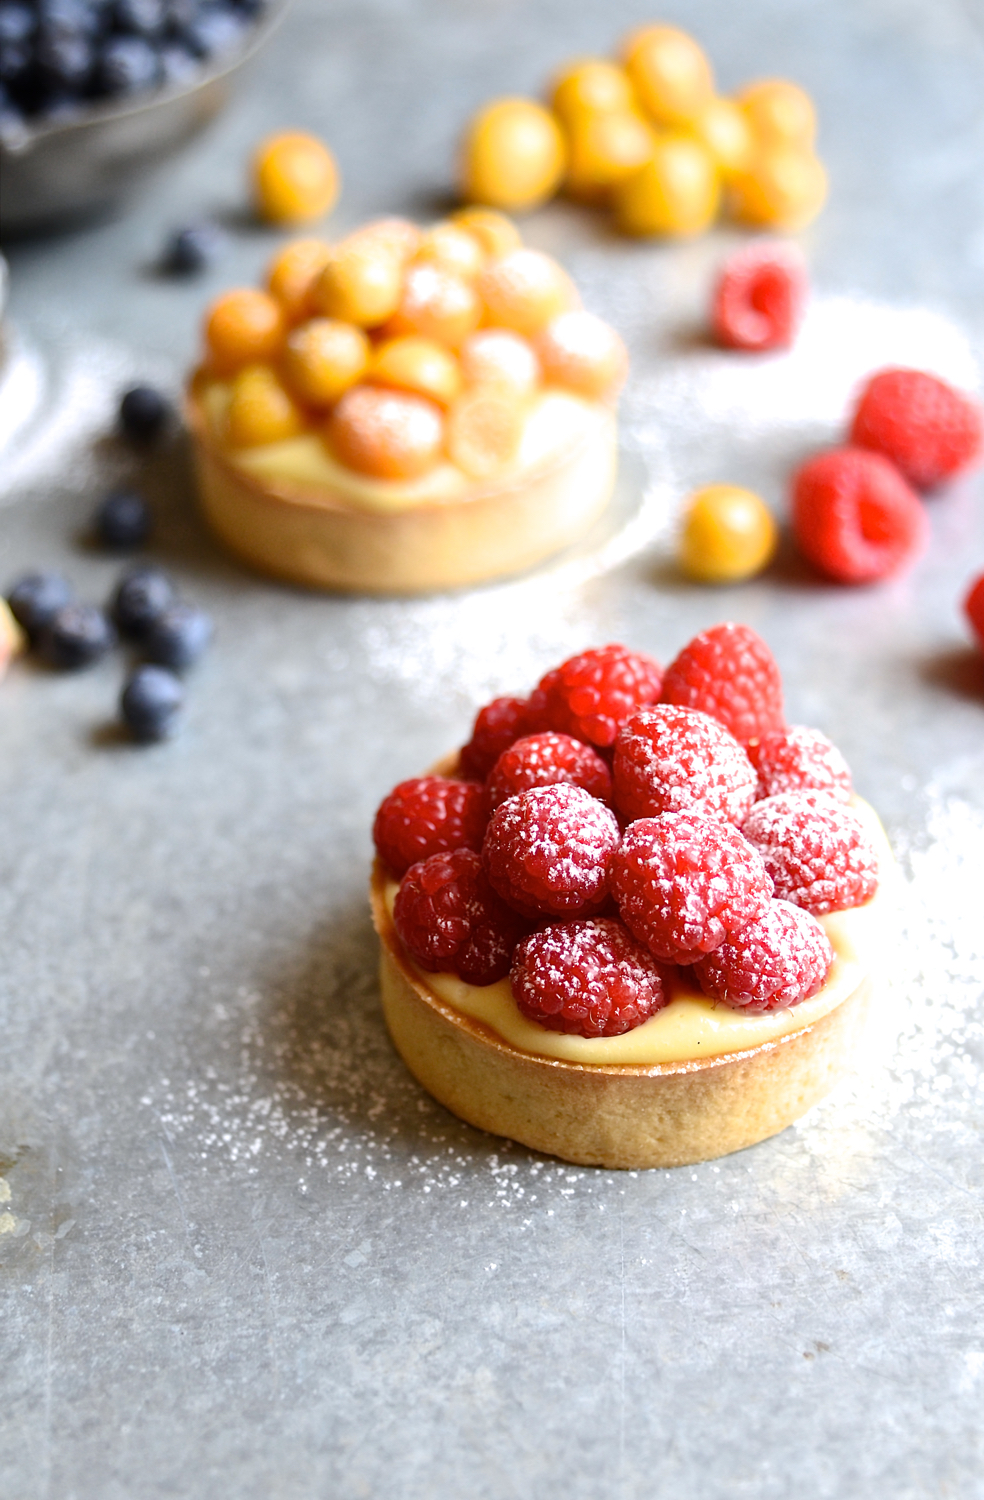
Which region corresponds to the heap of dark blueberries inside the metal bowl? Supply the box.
[0,0,269,134]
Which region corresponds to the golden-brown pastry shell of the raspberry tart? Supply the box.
[372,861,872,1169]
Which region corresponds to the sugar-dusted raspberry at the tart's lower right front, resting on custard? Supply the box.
[693,902,834,1011]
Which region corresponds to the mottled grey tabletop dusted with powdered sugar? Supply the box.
[0,0,984,1500]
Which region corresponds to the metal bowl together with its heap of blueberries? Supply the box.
[0,0,287,234]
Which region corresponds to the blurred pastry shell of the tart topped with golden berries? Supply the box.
[188,384,617,594]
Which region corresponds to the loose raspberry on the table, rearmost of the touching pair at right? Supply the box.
[851,369,984,489]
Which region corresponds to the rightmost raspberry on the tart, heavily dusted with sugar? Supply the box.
[743,792,878,917]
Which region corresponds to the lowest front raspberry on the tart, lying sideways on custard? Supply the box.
[512,917,669,1037]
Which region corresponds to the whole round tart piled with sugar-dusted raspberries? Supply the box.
[371,624,893,1167]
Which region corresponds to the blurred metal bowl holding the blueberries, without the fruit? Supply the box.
[0,0,290,234]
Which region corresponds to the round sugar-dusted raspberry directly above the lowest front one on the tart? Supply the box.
[482,783,620,917]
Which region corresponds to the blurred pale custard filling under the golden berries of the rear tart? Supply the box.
[198,380,608,512]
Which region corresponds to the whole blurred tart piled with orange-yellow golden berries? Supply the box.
[188,209,627,593]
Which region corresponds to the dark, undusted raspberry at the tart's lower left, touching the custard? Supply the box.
[393,849,527,984]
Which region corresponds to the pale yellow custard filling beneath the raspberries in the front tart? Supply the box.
[386,798,896,1067]
